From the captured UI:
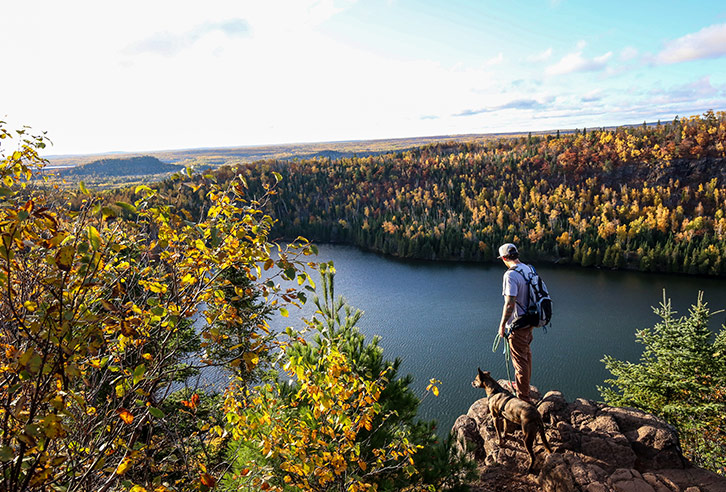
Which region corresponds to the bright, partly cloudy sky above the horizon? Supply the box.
[0,0,726,155]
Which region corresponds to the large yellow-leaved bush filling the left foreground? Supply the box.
[0,122,311,492]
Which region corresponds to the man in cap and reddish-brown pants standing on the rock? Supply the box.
[497,243,534,403]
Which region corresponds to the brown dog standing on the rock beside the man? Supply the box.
[471,369,552,473]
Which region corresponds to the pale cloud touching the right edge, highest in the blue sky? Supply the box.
[655,24,726,64]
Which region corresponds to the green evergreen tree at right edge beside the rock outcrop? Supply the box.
[599,293,726,474]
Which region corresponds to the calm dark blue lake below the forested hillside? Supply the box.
[272,245,726,434]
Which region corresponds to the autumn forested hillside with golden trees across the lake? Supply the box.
[105,112,726,275]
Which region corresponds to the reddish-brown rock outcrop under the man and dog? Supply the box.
[452,380,726,492]
